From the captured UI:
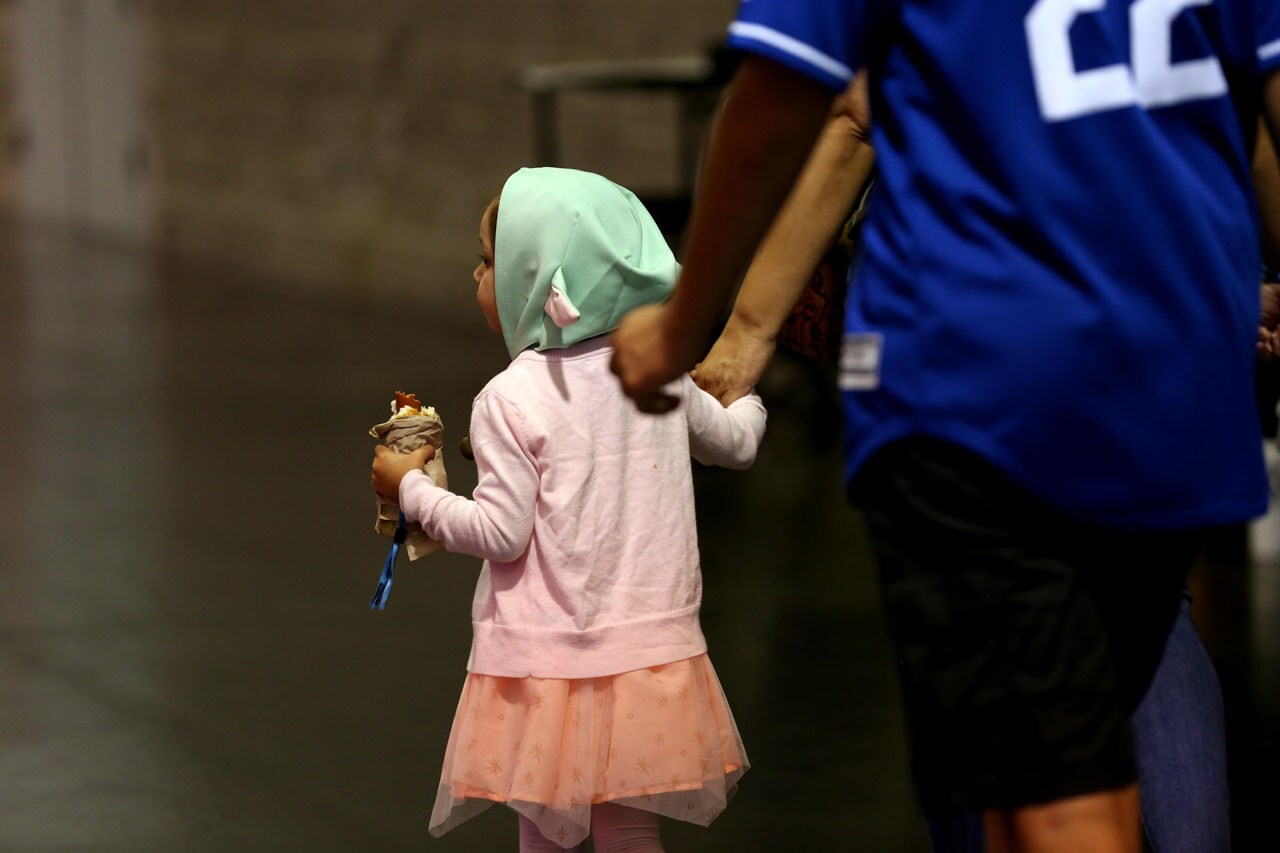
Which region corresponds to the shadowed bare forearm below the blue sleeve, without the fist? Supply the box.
[671,58,831,341]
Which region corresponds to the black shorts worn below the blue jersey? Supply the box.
[851,438,1199,815]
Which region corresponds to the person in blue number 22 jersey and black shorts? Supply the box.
[614,0,1280,852]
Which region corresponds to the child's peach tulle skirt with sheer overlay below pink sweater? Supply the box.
[431,654,749,847]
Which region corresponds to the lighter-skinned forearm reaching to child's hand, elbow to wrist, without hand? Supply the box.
[731,115,876,341]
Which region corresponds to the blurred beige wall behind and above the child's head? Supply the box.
[141,0,736,300]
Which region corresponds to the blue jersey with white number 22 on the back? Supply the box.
[730,0,1280,528]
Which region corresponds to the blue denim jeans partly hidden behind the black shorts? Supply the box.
[928,596,1231,853]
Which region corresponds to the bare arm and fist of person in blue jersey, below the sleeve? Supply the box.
[612,56,831,412]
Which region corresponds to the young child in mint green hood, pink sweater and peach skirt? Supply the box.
[374,169,765,853]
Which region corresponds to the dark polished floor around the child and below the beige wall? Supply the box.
[0,229,1280,853]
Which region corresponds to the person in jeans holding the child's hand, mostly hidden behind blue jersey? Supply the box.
[692,74,1280,853]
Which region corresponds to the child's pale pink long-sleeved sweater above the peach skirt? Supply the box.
[399,338,765,679]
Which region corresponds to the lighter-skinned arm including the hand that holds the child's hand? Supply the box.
[692,76,876,406]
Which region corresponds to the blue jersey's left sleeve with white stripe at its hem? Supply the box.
[728,0,886,91]
